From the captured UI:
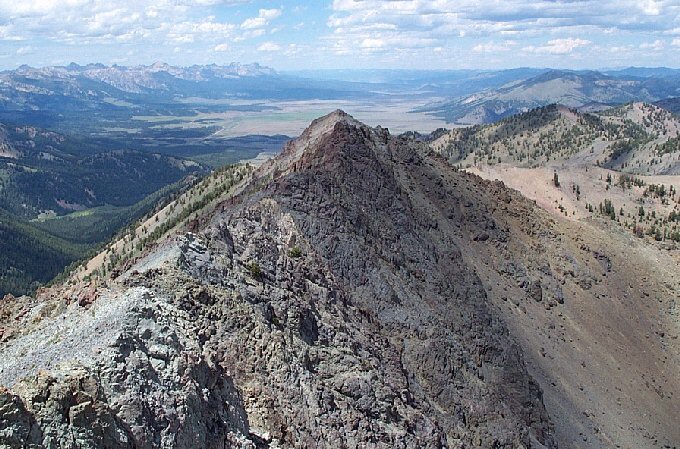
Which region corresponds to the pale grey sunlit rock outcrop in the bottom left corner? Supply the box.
[0,289,254,448]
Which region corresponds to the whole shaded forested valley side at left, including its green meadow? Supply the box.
[0,117,206,296]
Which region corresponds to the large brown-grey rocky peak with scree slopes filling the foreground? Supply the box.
[0,111,680,449]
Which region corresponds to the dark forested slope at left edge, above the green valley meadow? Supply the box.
[0,119,205,218]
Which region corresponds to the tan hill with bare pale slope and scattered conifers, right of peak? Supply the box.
[430,103,680,248]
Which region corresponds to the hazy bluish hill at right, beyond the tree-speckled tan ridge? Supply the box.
[418,69,680,124]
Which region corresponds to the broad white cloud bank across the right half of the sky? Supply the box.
[325,0,680,63]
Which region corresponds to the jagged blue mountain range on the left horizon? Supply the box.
[0,63,366,121]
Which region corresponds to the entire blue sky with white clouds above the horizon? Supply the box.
[0,0,680,70]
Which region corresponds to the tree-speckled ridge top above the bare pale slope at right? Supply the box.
[433,103,680,175]
